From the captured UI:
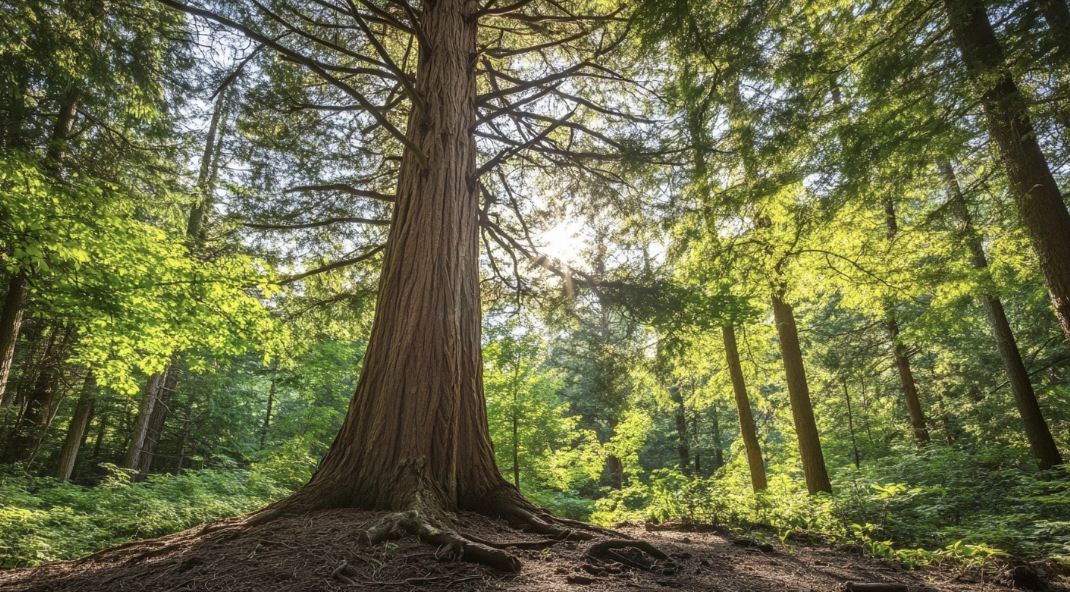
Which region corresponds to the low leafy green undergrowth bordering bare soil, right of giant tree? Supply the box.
[591,445,1070,565]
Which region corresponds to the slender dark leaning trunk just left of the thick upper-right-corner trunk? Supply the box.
[939,161,1063,470]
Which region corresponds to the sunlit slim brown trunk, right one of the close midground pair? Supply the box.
[773,292,832,494]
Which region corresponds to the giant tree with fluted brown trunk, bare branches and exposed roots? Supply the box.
[161,0,650,571]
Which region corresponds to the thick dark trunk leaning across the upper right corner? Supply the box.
[944,0,1070,348]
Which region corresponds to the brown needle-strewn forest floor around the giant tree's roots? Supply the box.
[0,510,1070,592]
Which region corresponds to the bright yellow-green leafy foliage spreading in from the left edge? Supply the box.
[0,152,274,392]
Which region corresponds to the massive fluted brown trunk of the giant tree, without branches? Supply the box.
[276,0,517,518]
